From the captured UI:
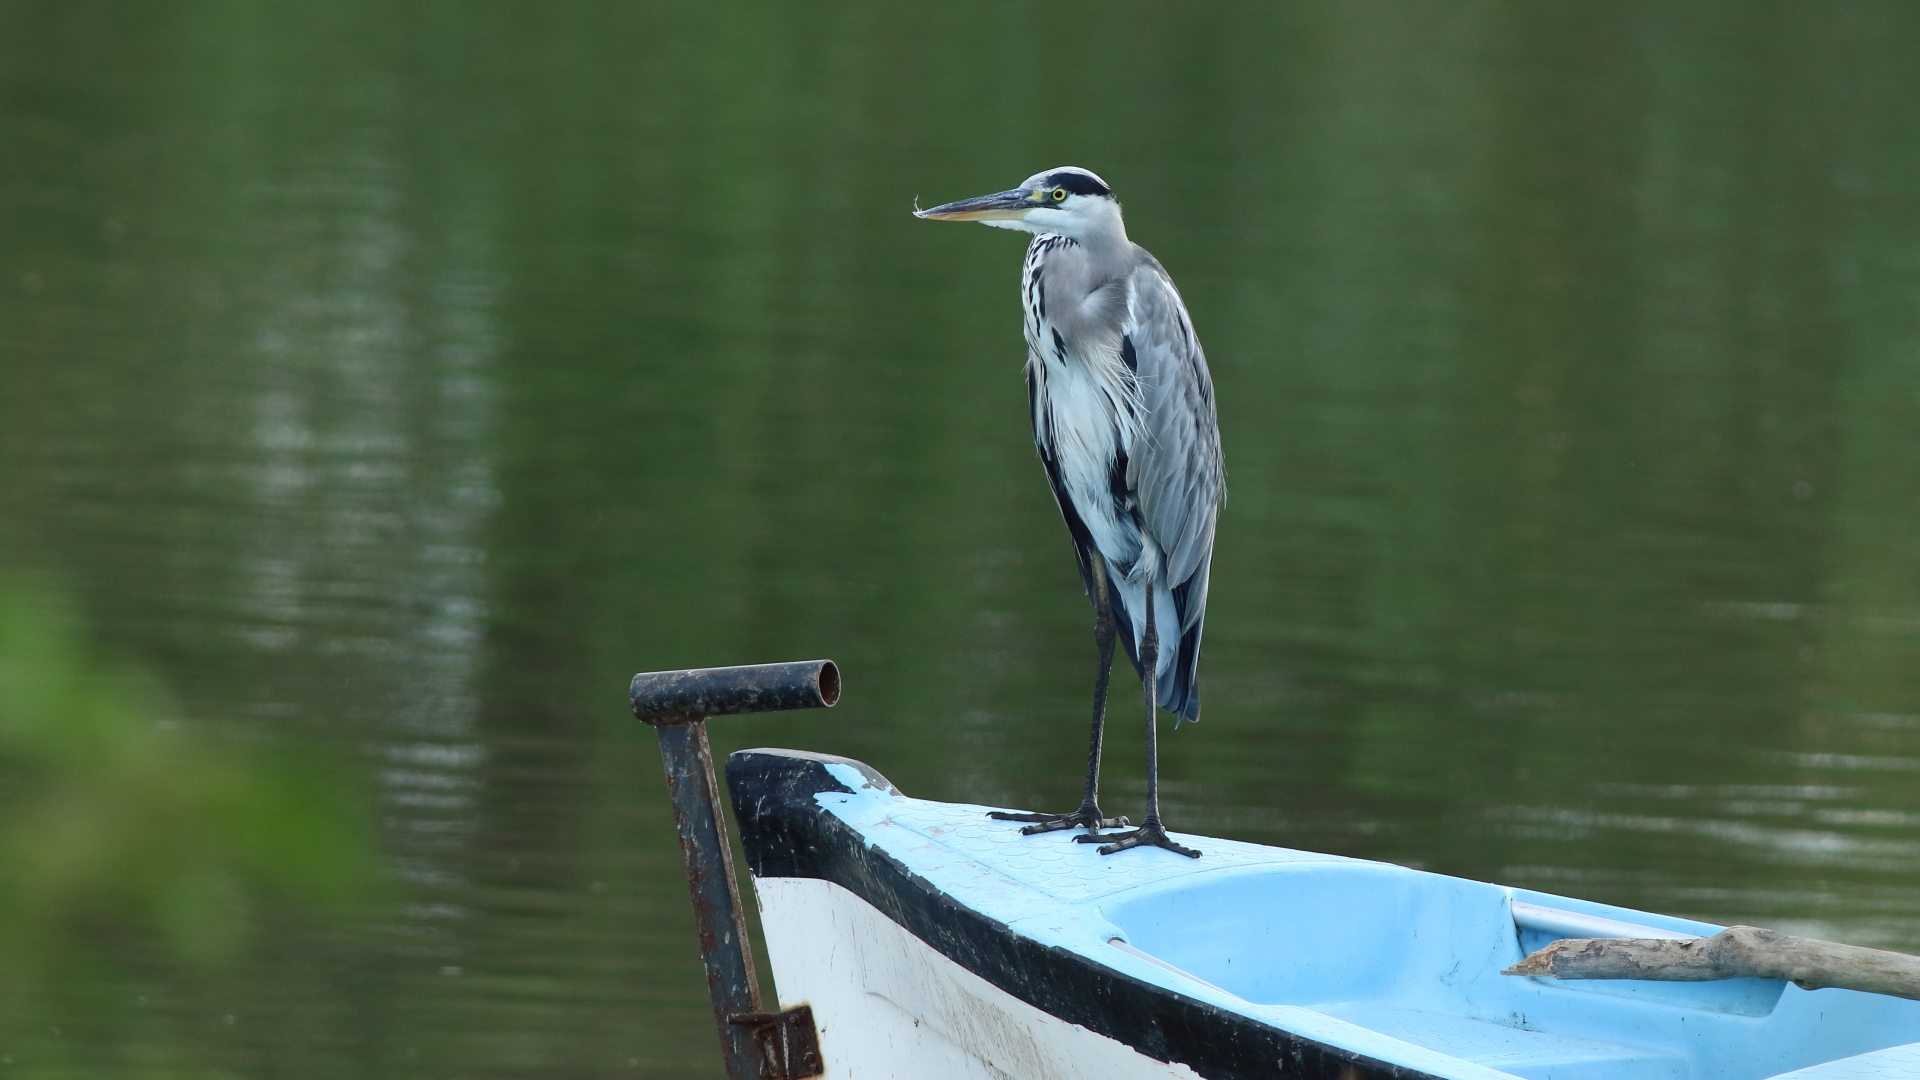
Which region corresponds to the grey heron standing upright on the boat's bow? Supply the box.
[914,165,1227,859]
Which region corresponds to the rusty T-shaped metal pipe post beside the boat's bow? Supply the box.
[628,659,839,1080]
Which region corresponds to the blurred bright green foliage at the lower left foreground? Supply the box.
[0,577,376,1074]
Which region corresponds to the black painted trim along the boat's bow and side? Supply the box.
[726,749,1442,1080]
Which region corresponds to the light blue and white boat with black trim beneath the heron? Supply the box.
[726,749,1920,1080]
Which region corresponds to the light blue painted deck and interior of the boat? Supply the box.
[814,765,1920,1080]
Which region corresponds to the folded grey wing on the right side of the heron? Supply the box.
[1121,256,1227,630]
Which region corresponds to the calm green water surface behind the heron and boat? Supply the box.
[0,0,1920,1078]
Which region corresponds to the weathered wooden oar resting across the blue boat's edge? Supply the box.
[1501,926,1920,999]
